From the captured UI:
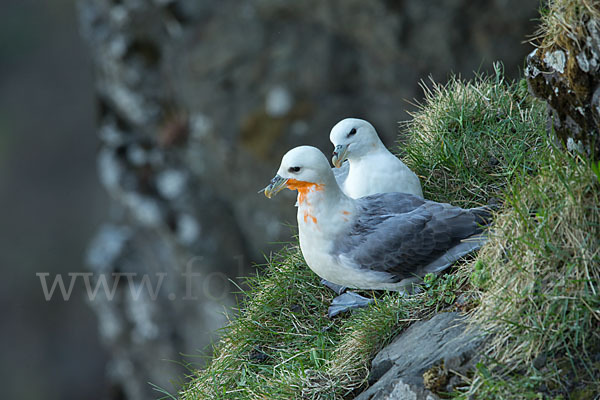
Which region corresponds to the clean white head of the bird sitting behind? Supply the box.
[329,118,383,168]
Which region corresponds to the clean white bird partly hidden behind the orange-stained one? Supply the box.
[329,118,423,199]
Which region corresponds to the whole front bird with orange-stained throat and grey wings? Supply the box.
[265,146,490,315]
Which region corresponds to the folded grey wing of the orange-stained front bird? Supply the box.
[338,196,490,282]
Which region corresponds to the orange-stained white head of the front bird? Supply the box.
[264,146,337,198]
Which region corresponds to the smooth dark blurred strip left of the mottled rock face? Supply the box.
[0,0,108,400]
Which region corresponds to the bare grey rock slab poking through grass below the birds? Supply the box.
[356,312,483,400]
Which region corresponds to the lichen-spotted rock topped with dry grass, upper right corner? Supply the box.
[525,0,600,159]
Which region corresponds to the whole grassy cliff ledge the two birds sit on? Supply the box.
[180,66,600,400]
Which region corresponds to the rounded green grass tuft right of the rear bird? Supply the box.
[401,63,546,207]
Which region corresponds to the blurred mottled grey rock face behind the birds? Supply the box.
[78,0,537,399]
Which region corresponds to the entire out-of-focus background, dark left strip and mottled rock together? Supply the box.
[0,0,539,399]
